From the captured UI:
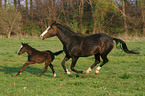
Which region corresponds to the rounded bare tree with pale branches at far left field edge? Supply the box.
[0,9,22,38]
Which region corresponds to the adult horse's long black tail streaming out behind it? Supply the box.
[113,38,140,54]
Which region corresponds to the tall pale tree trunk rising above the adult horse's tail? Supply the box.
[122,0,128,37]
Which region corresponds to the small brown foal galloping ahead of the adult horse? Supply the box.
[14,43,63,77]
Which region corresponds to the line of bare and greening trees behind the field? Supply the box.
[0,0,145,37]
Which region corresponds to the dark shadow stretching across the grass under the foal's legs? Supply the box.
[0,65,55,77]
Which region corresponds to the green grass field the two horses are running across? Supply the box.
[0,37,145,96]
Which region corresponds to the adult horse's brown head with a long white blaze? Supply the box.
[40,21,56,40]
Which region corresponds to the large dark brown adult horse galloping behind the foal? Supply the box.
[40,22,139,75]
